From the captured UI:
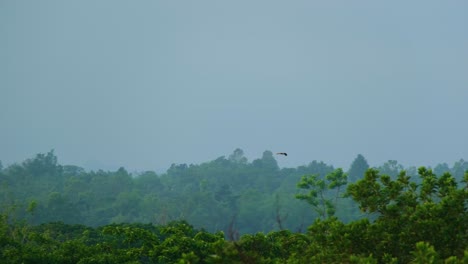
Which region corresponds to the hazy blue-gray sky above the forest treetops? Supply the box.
[0,0,468,171]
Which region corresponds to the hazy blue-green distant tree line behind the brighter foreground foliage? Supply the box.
[0,149,468,234]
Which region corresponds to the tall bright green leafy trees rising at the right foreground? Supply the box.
[348,167,468,262]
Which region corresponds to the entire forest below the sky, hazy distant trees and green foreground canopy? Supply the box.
[0,149,468,263]
